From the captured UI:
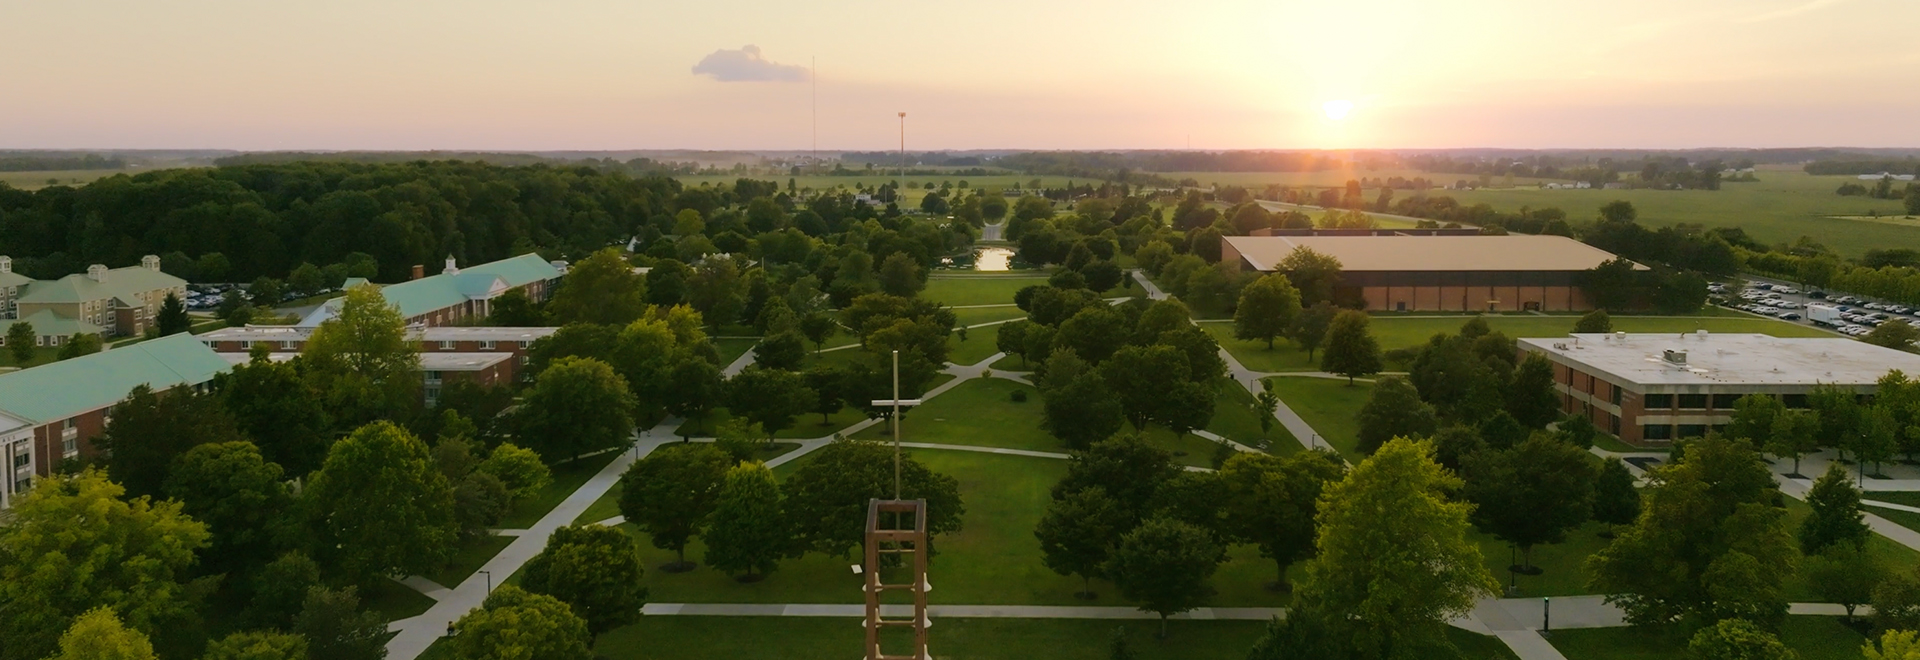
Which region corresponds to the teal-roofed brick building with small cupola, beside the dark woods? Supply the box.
[300,253,564,328]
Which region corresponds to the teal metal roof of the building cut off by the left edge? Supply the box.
[0,332,228,424]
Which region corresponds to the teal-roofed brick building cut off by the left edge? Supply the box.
[0,334,227,501]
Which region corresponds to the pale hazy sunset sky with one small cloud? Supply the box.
[0,0,1920,150]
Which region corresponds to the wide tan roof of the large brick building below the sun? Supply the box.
[1223,234,1635,272]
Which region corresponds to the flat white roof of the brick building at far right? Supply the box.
[1519,332,1920,388]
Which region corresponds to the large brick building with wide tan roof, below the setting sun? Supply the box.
[1221,234,1615,311]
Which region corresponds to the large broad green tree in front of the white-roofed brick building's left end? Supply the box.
[1586,437,1797,625]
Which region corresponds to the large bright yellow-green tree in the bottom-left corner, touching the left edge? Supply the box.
[0,468,207,660]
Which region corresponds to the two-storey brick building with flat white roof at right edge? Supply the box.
[1519,330,1920,445]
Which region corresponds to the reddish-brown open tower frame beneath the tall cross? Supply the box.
[862,499,933,660]
